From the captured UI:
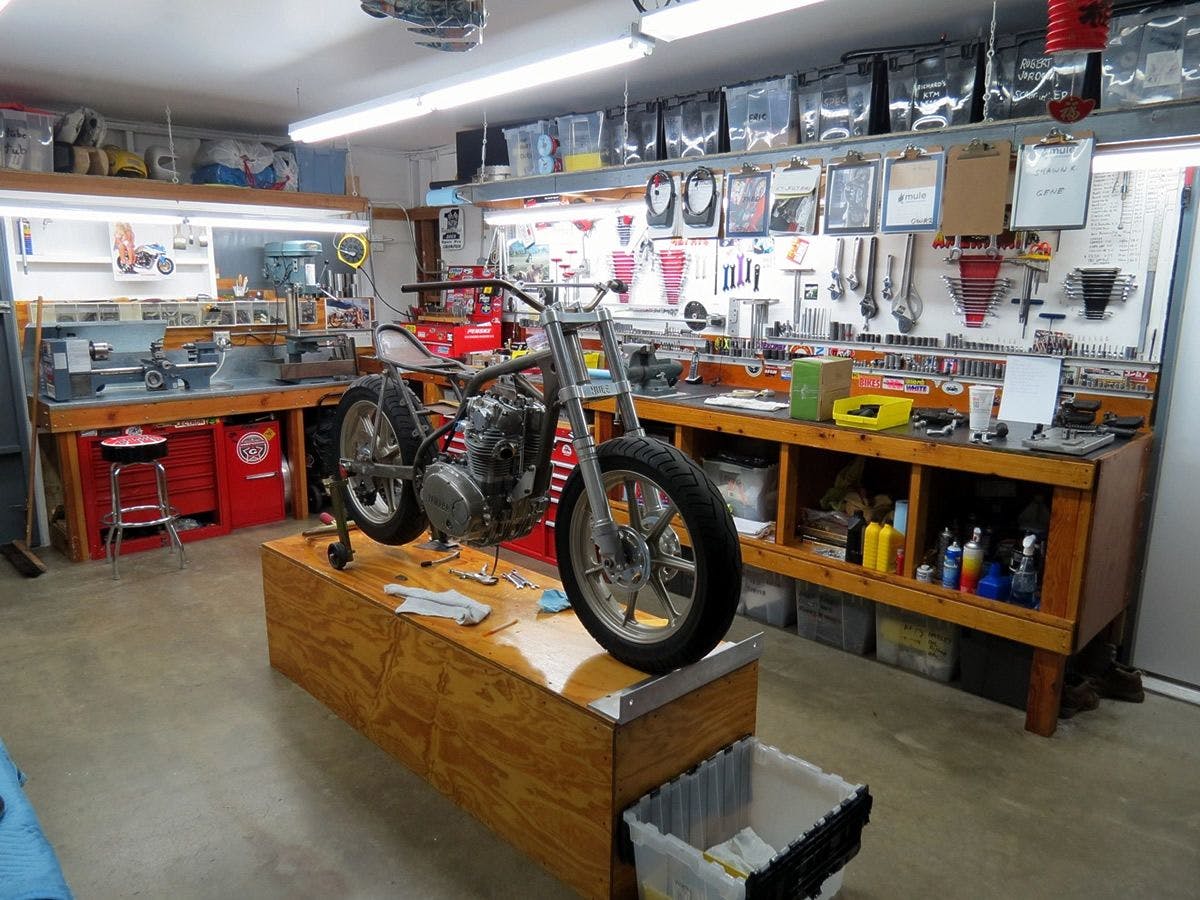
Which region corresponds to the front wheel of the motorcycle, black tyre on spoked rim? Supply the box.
[556,438,742,672]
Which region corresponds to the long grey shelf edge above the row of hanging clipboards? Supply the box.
[462,101,1200,203]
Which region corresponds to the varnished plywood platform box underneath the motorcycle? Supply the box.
[263,533,758,898]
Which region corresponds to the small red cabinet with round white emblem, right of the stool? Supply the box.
[221,419,284,528]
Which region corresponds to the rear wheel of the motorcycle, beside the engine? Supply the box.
[337,376,427,544]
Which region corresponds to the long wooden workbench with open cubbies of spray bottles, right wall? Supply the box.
[589,384,1151,736]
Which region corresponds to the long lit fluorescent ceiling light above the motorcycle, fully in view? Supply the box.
[288,35,654,144]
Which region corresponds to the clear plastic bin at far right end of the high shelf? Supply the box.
[1102,2,1200,109]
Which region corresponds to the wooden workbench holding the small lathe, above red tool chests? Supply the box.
[37,377,349,562]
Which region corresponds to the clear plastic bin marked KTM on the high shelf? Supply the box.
[888,43,982,133]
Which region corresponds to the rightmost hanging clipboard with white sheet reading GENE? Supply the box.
[1012,133,1096,230]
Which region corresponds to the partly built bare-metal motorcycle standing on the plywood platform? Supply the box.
[336,278,742,673]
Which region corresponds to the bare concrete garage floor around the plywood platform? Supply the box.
[0,522,1200,900]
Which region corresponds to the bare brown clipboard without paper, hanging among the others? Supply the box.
[942,139,1013,234]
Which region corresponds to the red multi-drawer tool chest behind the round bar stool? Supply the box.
[79,421,229,559]
